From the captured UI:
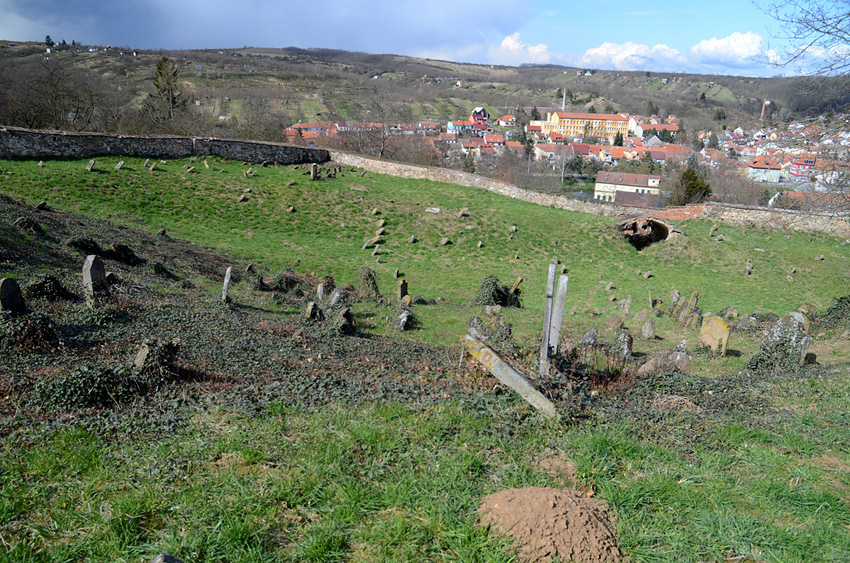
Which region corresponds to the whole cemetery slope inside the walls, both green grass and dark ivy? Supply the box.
[0,158,850,563]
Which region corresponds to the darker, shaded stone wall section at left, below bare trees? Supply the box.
[0,127,330,164]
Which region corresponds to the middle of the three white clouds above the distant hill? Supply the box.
[575,41,685,71]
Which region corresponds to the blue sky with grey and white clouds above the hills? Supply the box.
[0,0,808,76]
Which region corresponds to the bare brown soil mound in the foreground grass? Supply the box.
[478,487,621,563]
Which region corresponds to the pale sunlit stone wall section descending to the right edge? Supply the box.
[331,151,850,238]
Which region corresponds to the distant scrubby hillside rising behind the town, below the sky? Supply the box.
[0,42,846,139]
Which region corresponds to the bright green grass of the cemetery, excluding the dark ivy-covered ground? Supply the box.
[0,159,850,563]
